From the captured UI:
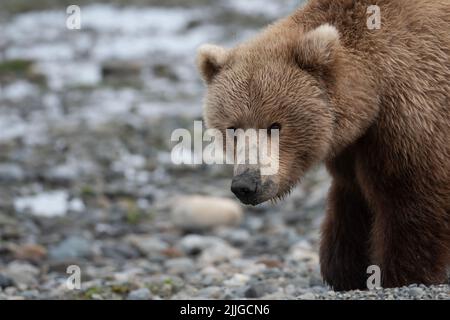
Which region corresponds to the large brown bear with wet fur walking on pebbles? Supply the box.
[198,0,450,290]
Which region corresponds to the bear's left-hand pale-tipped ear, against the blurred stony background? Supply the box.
[197,44,228,83]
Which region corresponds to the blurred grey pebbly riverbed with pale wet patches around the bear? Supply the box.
[0,0,450,299]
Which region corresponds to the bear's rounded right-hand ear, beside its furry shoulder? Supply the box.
[297,24,340,70]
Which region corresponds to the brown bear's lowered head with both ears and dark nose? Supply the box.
[197,24,340,205]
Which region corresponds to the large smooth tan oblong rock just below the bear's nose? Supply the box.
[171,196,243,230]
